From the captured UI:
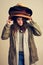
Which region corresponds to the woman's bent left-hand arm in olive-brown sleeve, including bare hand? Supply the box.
[1,19,13,40]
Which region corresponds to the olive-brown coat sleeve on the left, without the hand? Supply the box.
[1,24,10,40]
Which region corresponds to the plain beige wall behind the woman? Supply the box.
[0,0,43,65]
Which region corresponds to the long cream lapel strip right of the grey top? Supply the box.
[23,29,30,65]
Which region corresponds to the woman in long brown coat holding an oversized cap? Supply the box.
[1,5,41,65]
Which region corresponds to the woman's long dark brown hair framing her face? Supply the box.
[11,16,27,32]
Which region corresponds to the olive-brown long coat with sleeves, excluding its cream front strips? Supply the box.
[1,21,41,65]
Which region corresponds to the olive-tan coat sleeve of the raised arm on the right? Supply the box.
[30,20,41,36]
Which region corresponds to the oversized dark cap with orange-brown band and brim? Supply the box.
[8,4,32,19]
